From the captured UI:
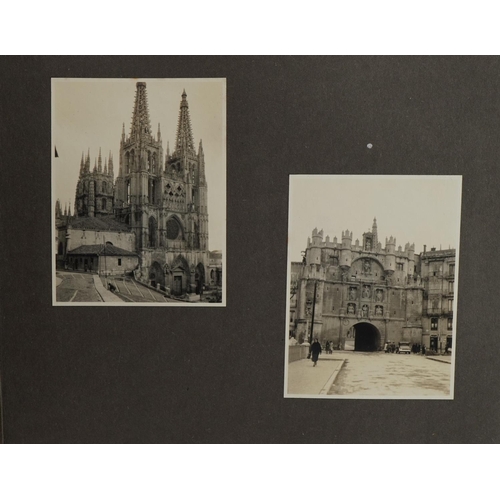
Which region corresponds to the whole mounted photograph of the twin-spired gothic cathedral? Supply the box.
[52,78,226,306]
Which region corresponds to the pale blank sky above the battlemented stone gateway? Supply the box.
[288,175,462,261]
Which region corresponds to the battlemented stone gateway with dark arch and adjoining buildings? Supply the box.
[290,220,455,352]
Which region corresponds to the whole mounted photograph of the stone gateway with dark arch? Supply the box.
[285,175,462,399]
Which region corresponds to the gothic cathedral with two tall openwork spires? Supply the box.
[56,82,215,295]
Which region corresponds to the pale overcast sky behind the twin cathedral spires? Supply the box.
[52,78,226,251]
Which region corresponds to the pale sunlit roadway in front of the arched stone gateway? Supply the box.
[328,352,452,399]
